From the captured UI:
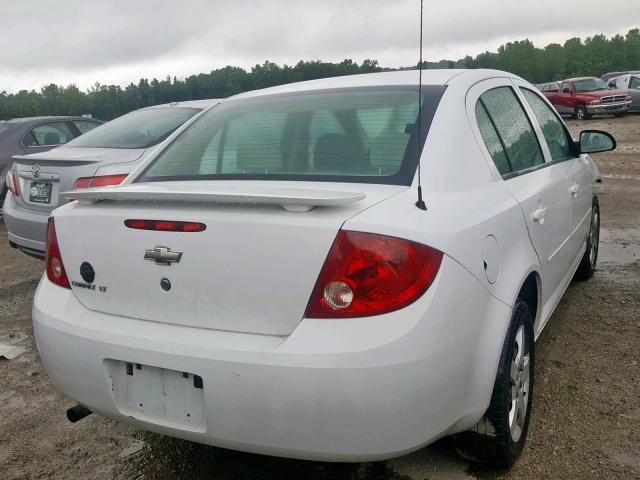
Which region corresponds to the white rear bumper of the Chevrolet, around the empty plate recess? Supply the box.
[33,257,511,461]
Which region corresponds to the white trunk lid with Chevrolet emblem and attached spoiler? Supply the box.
[56,181,407,335]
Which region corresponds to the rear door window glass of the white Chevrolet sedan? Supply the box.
[479,87,544,173]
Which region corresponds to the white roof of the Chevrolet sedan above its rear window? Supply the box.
[229,69,518,100]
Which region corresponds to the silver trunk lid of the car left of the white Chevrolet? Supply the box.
[13,147,145,211]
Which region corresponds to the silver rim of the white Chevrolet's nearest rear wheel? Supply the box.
[509,325,531,443]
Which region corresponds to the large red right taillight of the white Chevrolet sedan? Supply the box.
[305,230,442,318]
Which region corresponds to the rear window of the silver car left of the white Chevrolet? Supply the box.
[66,107,200,148]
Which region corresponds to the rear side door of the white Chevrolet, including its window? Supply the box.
[469,79,571,318]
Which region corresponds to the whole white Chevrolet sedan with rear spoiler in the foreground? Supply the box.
[33,70,615,466]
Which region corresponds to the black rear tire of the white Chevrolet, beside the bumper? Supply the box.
[453,299,535,468]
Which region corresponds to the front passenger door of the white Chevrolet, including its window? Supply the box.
[515,81,593,266]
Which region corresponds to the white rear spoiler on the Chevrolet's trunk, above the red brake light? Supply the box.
[61,183,366,212]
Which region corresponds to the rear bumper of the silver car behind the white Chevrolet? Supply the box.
[2,192,50,258]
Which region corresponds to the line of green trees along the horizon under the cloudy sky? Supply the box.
[0,28,640,120]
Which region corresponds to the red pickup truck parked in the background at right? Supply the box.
[542,77,632,120]
